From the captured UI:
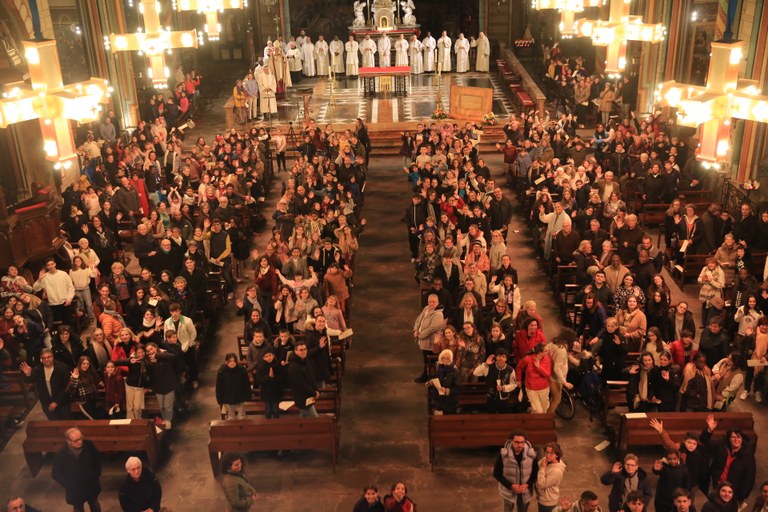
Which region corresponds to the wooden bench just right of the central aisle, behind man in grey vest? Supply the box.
[428,414,557,469]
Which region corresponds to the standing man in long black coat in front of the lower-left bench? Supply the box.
[51,428,101,512]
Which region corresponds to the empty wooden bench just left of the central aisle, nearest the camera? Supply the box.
[208,416,339,475]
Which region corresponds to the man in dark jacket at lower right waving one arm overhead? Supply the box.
[701,414,756,502]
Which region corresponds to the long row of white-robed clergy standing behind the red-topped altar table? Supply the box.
[264,30,491,80]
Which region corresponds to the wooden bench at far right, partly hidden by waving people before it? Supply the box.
[617,412,757,454]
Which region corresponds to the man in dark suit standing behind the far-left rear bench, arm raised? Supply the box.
[20,348,72,420]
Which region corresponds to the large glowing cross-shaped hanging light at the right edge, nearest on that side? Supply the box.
[656,41,768,167]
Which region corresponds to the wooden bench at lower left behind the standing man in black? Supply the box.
[22,420,161,476]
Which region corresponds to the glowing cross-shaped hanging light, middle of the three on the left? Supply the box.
[104,0,202,88]
